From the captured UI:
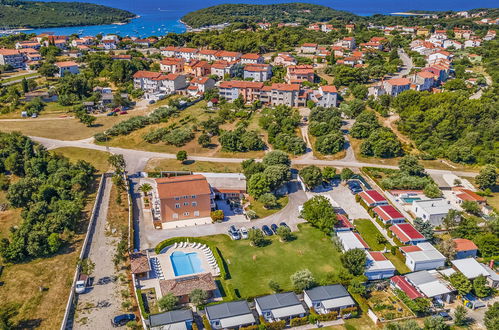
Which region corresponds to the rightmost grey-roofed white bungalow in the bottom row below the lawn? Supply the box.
[303,284,355,314]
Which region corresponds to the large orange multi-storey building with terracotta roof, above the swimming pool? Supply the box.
[154,174,215,225]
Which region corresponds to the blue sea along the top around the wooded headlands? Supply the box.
[20,0,498,38]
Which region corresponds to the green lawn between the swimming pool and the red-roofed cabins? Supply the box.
[207,224,342,298]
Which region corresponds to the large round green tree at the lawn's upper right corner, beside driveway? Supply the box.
[301,196,338,234]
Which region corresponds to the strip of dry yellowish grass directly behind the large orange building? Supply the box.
[145,158,242,173]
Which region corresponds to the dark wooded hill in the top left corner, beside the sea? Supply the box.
[0,0,135,29]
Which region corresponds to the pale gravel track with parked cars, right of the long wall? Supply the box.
[73,177,122,329]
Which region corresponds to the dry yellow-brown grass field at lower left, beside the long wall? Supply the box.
[0,175,102,329]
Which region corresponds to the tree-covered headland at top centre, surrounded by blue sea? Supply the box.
[182,3,356,28]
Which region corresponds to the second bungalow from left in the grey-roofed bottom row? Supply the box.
[205,300,256,329]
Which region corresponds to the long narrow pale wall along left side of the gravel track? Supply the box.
[61,173,108,330]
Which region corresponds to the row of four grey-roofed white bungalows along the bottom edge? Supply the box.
[146,284,356,330]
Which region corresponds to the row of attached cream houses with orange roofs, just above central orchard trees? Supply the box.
[218,80,338,107]
